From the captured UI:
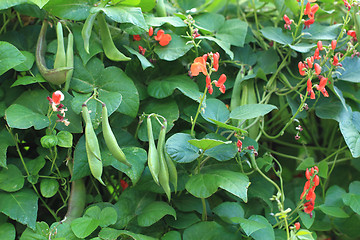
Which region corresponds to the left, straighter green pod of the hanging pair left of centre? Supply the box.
[82,104,105,185]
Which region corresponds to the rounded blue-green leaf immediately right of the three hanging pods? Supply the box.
[166,133,200,163]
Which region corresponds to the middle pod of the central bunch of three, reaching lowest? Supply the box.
[157,120,171,201]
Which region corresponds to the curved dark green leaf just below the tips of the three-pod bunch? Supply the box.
[137,202,176,227]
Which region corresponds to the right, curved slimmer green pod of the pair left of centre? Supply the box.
[102,104,131,167]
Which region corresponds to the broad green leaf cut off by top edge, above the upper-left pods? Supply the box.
[44,0,96,21]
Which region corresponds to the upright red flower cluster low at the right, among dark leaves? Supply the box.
[300,166,320,217]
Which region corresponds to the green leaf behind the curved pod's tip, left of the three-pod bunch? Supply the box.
[101,147,147,185]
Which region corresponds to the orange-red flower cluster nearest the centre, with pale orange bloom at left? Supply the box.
[190,52,226,94]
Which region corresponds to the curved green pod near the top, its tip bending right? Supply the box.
[97,14,131,61]
